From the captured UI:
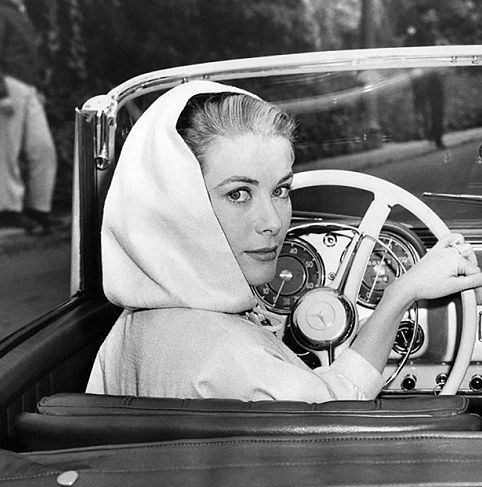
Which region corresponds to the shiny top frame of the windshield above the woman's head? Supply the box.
[83,45,482,117]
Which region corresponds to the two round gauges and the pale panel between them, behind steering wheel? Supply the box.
[255,223,420,314]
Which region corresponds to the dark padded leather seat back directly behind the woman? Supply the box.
[14,394,480,451]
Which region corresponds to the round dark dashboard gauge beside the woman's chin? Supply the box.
[254,238,325,314]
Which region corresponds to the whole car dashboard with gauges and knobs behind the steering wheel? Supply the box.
[254,219,482,393]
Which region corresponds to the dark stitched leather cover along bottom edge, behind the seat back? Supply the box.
[7,431,482,487]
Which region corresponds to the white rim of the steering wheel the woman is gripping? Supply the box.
[293,169,477,395]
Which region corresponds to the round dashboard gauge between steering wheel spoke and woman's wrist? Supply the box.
[358,233,417,308]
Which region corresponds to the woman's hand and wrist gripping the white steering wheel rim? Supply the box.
[392,233,482,304]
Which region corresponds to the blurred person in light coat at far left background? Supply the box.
[0,0,62,234]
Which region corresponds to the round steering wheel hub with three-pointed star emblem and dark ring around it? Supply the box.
[291,287,356,351]
